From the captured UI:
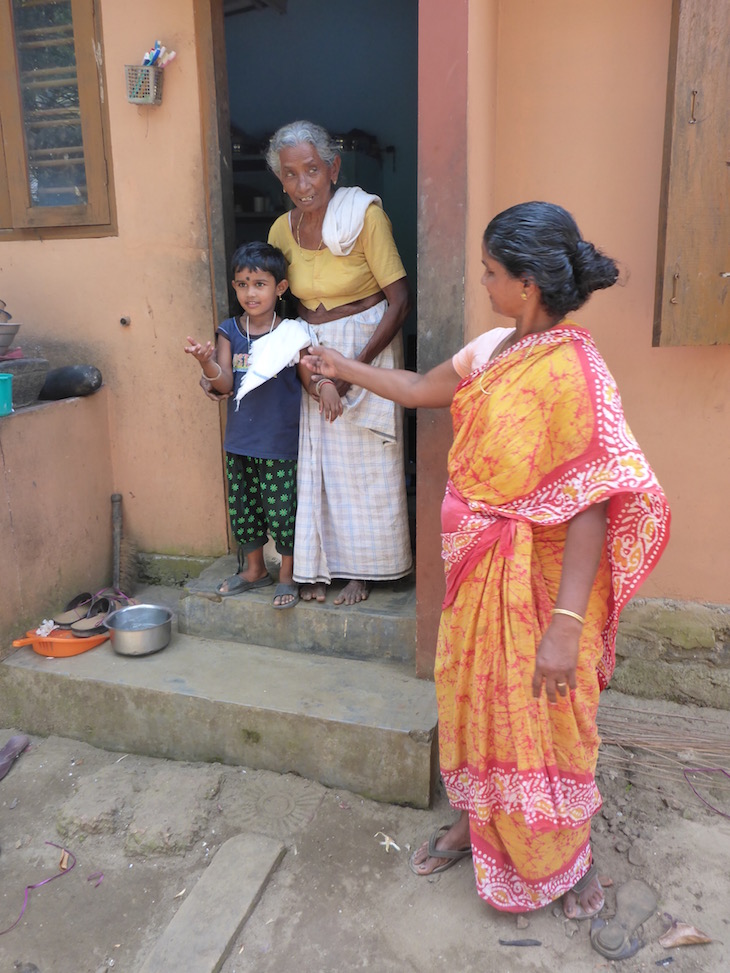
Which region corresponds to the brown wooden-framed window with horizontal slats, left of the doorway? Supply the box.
[0,0,110,228]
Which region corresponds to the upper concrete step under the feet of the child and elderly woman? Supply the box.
[178,556,416,672]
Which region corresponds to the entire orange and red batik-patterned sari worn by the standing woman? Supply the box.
[435,321,669,912]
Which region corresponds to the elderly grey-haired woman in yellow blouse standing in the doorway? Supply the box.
[267,121,411,605]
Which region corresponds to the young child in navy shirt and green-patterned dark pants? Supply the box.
[185,243,302,608]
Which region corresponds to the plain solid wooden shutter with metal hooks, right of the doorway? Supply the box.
[654,0,730,345]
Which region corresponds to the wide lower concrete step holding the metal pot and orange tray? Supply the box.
[0,600,436,807]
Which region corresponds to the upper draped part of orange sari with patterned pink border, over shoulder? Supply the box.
[442,321,669,688]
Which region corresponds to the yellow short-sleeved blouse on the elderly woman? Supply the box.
[269,204,406,311]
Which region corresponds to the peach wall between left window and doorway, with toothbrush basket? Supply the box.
[0,0,227,556]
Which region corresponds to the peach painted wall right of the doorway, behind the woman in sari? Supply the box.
[466,0,730,603]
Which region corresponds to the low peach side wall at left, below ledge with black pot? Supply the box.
[0,388,114,640]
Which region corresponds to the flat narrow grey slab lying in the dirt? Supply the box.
[140,834,286,973]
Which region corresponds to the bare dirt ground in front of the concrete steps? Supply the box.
[0,692,730,973]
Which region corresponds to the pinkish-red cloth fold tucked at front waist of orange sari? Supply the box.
[441,480,522,609]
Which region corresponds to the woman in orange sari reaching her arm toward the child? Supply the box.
[305,203,669,918]
